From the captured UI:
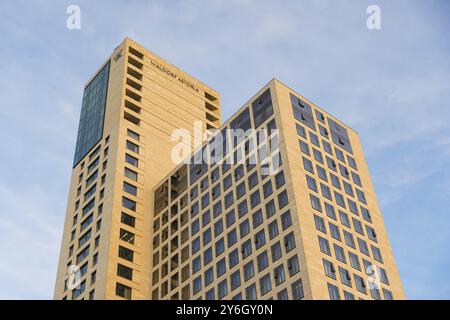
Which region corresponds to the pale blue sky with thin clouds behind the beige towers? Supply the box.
[0,0,450,299]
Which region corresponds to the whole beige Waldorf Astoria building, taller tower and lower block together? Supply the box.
[55,39,405,299]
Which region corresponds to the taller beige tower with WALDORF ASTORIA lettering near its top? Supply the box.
[54,38,221,299]
